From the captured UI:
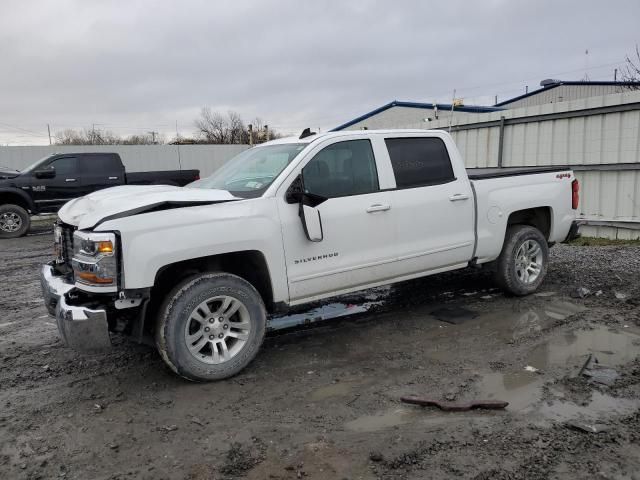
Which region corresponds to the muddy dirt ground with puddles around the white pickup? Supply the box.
[0,226,640,480]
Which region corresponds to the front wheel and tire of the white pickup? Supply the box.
[156,273,267,382]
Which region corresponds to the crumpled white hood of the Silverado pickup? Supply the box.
[58,185,241,229]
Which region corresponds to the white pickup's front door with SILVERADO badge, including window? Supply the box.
[278,139,395,304]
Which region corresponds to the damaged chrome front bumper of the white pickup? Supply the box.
[40,264,111,352]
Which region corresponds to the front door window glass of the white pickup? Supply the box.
[303,140,379,198]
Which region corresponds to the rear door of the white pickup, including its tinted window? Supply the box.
[384,134,474,275]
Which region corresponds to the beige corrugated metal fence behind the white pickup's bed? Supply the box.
[420,92,640,239]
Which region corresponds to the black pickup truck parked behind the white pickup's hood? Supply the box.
[0,153,200,238]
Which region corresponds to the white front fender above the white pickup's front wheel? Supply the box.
[96,199,288,301]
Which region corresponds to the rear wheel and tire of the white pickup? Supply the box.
[494,225,549,296]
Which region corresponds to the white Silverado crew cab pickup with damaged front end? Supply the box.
[41,130,578,381]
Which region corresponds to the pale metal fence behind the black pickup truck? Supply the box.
[0,145,249,177]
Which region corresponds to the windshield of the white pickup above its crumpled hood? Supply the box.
[187,143,307,198]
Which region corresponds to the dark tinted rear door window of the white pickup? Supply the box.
[385,137,455,188]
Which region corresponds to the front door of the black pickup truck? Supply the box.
[31,155,80,212]
